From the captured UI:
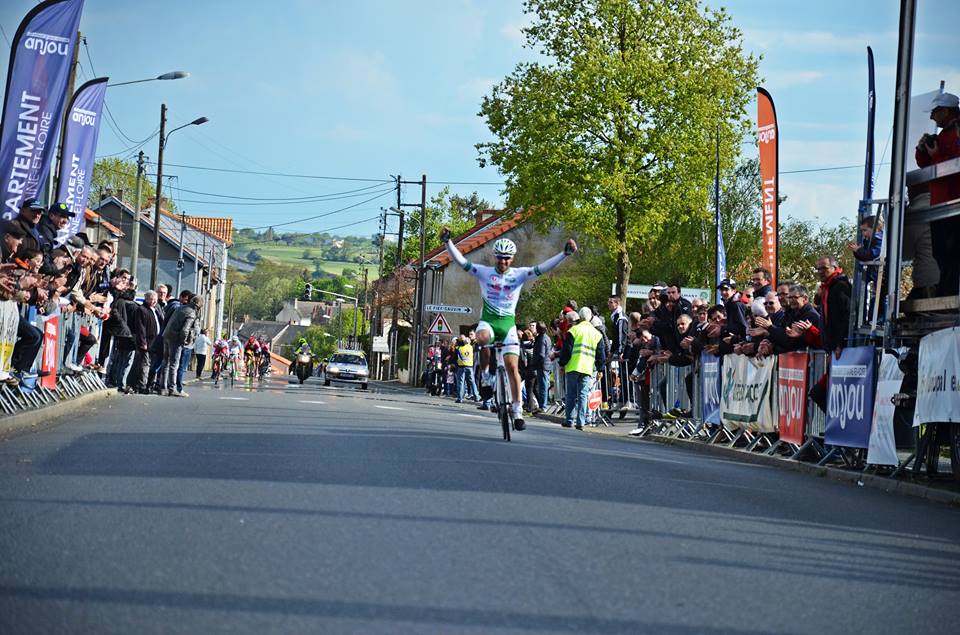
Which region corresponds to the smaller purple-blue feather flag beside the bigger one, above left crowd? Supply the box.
[56,77,108,244]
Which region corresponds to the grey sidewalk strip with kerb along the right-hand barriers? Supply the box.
[376,381,960,506]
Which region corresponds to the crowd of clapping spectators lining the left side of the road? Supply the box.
[0,199,205,397]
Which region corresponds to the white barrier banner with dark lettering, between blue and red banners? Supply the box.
[720,355,777,432]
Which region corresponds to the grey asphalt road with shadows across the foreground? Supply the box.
[0,378,960,634]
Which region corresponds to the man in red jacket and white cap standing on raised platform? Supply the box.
[916,93,960,296]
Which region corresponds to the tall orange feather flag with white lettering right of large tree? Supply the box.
[757,88,780,286]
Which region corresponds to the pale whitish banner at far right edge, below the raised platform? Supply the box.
[913,326,960,426]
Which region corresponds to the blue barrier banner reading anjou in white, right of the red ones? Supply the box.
[824,346,876,448]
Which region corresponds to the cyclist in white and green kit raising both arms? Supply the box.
[440,227,577,430]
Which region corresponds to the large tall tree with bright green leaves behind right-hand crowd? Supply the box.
[477,0,757,306]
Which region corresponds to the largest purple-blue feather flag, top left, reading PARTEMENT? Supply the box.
[0,0,83,219]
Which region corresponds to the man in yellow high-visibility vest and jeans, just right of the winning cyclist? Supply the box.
[559,307,607,430]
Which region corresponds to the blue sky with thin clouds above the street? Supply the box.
[0,0,960,235]
